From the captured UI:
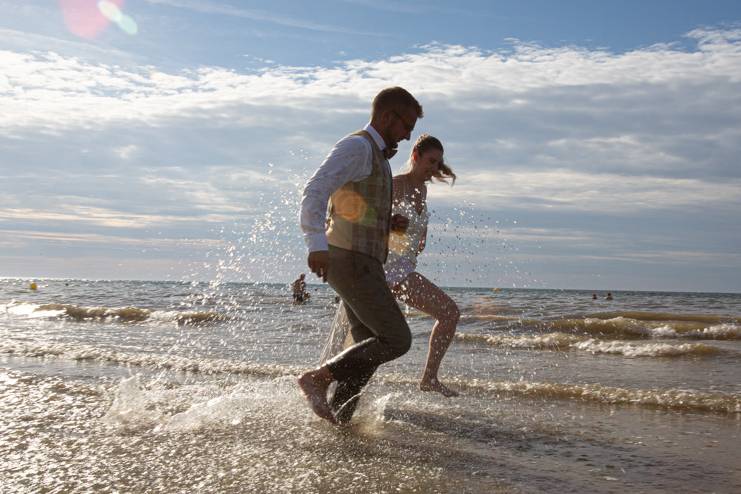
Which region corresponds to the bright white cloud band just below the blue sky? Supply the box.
[0,31,741,128]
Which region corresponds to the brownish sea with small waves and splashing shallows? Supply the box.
[0,279,741,494]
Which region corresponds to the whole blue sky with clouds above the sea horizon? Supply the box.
[0,0,741,292]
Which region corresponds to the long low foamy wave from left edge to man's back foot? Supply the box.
[0,340,305,377]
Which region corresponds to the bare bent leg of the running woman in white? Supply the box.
[392,273,460,396]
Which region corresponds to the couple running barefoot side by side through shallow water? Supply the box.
[298,87,460,423]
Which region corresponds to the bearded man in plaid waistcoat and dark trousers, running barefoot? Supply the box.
[298,87,423,423]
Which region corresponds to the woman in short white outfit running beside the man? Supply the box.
[385,134,460,396]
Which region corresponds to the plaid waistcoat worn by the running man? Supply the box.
[327,130,392,264]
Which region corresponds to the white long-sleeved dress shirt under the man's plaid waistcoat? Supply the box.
[300,124,386,252]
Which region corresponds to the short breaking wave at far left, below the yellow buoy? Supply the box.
[0,303,228,326]
